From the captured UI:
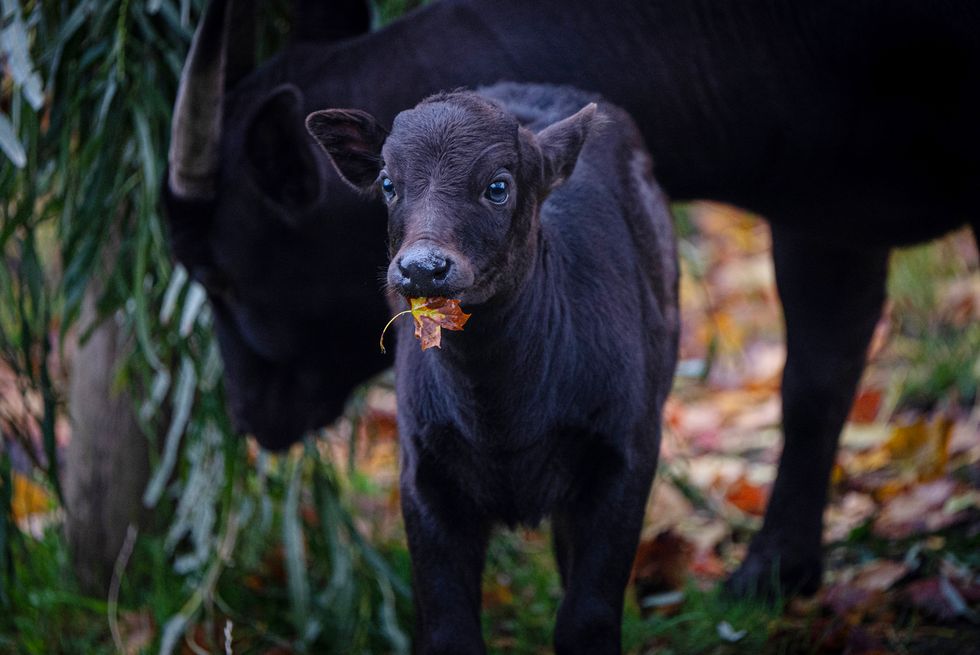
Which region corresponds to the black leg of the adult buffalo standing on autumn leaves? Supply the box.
[726,225,888,597]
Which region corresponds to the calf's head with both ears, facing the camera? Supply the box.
[306,92,596,304]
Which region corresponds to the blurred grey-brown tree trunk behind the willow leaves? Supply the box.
[61,276,150,596]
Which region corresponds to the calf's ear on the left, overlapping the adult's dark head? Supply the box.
[306,109,388,191]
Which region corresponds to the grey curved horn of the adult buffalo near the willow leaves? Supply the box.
[168,0,254,200]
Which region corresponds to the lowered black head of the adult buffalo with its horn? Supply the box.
[163,1,390,448]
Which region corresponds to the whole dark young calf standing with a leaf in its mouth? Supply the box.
[307,84,678,654]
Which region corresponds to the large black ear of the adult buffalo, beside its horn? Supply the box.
[245,84,321,209]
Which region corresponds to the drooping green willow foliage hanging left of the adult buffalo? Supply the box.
[0,0,407,652]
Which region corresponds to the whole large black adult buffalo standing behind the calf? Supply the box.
[165,0,980,591]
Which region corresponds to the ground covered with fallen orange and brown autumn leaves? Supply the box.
[0,204,980,655]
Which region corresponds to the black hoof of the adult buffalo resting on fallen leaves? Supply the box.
[724,548,823,602]
